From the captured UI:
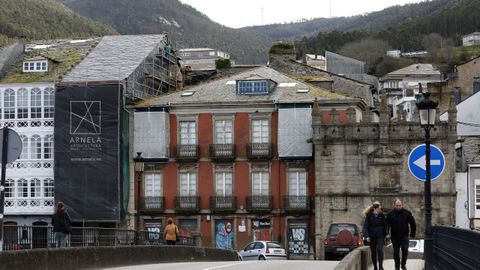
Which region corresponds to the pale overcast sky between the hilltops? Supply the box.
[180,0,425,28]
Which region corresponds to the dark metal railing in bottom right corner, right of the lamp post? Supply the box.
[432,226,480,270]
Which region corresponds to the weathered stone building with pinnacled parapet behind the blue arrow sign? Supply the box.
[312,94,457,258]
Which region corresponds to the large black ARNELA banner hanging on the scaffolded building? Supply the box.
[54,85,121,221]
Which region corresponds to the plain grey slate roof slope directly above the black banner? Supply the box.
[62,35,165,82]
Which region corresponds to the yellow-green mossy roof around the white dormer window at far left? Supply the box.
[0,41,96,83]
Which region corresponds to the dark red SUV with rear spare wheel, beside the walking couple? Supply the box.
[324,223,362,260]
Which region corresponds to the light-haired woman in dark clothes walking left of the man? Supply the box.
[363,202,388,270]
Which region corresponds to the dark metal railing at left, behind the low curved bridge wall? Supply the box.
[3,225,195,250]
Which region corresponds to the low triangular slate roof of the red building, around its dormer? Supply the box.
[137,67,354,107]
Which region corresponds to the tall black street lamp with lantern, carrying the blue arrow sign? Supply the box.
[416,92,438,270]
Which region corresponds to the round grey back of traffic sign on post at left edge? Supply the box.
[0,127,22,251]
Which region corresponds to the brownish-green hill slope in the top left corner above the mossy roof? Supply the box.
[0,0,118,40]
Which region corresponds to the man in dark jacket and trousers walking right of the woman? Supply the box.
[387,198,417,270]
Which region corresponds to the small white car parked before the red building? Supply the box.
[238,241,287,261]
